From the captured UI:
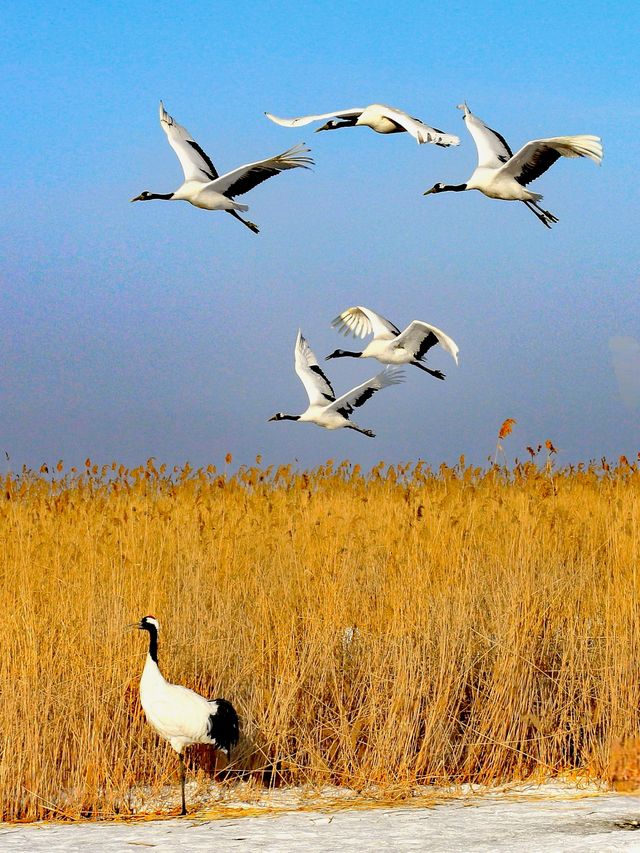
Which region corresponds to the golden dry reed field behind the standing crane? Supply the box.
[0,443,640,820]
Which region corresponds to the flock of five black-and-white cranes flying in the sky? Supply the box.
[131,101,602,438]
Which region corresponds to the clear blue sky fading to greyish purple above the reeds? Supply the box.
[0,0,640,469]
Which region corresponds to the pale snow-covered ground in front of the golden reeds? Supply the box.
[0,786,640,853]
